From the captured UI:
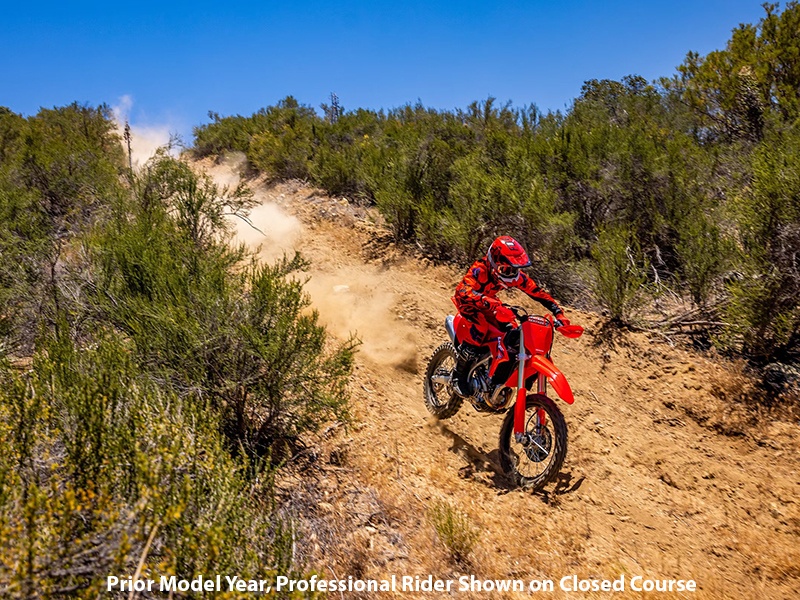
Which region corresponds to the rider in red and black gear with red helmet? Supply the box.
[453,235,569,397]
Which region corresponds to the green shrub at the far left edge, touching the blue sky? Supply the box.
[0,104,124,355]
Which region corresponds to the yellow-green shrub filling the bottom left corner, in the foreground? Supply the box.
[0,335,290,598]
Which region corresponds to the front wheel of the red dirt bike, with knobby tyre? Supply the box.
[500,394,567,491]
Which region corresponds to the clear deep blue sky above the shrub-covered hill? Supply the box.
[0,0,764,143]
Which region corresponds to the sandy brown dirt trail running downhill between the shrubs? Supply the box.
[209,157,800,599]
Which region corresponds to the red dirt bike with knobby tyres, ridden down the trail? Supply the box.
[424,306,583,490]
